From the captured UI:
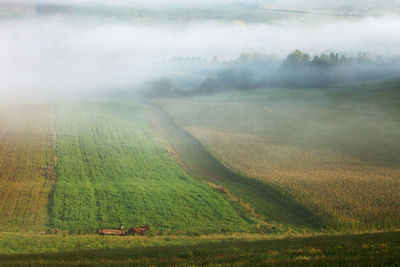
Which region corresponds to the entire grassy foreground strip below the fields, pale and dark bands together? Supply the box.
[0,232,400,266]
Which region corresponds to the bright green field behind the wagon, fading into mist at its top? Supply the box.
[50,103,255,231]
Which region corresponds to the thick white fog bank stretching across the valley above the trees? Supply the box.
[0,7,400,101]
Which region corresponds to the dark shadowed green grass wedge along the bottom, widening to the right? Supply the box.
[0,232,400,266]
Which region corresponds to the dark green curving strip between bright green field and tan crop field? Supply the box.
[147,102,322,228]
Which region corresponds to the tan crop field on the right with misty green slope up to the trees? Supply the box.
[159,80,400,229]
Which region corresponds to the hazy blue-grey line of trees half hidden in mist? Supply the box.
[145,50,400,97]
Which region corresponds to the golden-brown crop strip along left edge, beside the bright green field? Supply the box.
[0,104,56,231]
